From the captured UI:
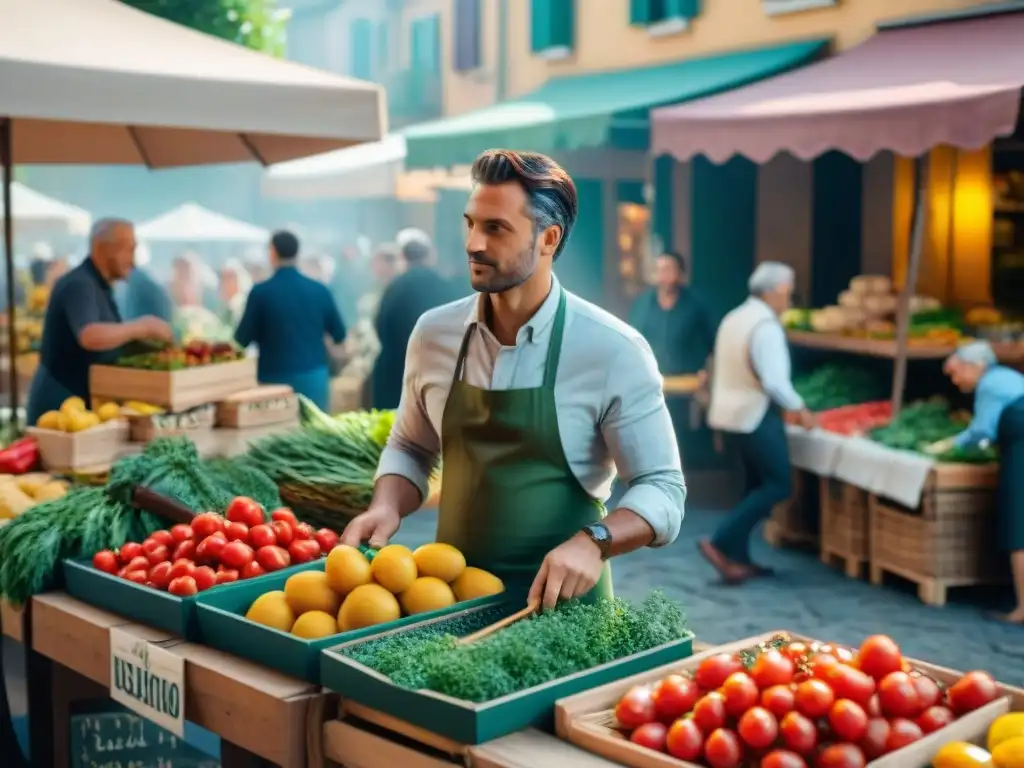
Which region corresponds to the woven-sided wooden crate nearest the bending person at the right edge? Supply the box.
[868,464,1007,605]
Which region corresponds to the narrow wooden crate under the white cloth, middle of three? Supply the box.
[820,477,870,579]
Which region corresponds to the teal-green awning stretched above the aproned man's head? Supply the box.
[403,40,828,168]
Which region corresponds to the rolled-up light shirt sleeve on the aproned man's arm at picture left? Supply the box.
[377,324,441,499]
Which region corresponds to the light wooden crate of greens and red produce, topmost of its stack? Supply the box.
[89,357,256,411]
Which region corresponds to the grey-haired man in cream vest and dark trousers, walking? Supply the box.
[699,261,814,584]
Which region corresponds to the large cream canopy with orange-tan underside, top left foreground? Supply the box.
[0,0,386,168]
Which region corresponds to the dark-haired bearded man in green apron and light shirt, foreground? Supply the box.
[342,150,686,607]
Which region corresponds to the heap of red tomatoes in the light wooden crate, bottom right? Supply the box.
[614,635,999,768]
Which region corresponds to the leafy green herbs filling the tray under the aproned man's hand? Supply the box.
[342,592,686,701]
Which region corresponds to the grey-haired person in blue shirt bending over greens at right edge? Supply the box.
[929,341,1024,624]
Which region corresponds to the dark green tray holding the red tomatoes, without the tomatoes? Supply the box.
[63,560,323,640]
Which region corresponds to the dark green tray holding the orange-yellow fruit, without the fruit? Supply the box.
[198,560,503,685]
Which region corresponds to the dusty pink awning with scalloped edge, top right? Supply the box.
[651,6,1024,163]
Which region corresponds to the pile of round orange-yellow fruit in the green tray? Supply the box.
[240,543,505,640]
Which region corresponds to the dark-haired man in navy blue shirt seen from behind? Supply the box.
[234,231,345,411]
